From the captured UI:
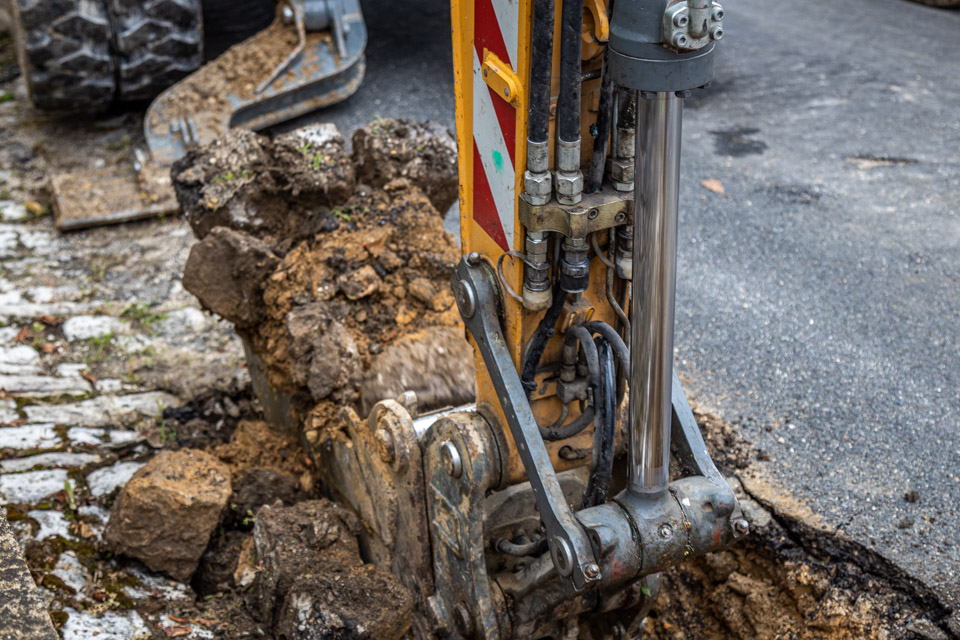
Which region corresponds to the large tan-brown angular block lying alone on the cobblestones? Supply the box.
[104,449,231,581]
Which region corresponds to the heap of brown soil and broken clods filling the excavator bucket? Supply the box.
[173,120,475,450]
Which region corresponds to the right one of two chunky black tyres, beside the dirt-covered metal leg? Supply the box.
[106,0,203,100]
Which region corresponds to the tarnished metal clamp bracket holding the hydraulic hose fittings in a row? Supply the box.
[519,186,633,238]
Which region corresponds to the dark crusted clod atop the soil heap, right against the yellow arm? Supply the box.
[353,118,459,215]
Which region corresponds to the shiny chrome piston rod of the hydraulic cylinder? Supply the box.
[629,92,683,493]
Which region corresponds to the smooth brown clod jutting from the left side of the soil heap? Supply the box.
[183,227,280,327]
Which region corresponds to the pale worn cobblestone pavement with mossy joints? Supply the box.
[0,75,247,640]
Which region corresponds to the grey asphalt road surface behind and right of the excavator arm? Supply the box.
[302,0,960,631]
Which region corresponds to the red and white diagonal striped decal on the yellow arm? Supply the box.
[473,0,520,251]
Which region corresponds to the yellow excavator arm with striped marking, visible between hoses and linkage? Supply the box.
[452,0,616,484]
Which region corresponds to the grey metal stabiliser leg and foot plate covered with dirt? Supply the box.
[51,0,367,231]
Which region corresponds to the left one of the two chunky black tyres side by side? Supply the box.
[11,0,114,109]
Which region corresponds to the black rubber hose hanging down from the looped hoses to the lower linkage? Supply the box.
[580,338,617,509]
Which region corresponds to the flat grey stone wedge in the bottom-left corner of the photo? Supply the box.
[0,510,57,640]
